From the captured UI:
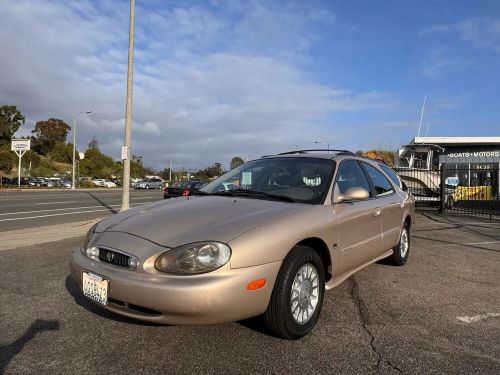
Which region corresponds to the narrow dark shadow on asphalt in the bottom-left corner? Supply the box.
[0,319,60,374]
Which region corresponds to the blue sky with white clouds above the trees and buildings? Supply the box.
[0,0,500,170]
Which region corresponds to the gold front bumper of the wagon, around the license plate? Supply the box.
[70,249,282,325]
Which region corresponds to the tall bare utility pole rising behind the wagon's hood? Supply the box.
[120,0,135,211]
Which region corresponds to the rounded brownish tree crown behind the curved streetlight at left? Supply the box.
[31,118,71,155]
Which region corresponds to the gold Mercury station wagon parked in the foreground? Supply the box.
[70,150,414,339]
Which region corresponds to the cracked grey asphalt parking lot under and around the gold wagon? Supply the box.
[0,215,500,374]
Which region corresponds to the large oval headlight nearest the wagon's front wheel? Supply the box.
[155,241,231,275]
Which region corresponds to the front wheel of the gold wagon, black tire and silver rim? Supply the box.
[263,245,325,340]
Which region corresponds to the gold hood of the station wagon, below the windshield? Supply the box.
[96,196,308,247]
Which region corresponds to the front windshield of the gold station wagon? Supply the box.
[201,157,335,204]
